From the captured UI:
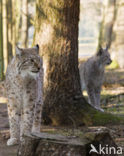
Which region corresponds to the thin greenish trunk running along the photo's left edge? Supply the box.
[0,0,4,80]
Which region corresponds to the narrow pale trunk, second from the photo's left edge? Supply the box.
[2,0,8,73]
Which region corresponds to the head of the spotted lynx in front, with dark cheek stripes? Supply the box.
[16,45,42,77]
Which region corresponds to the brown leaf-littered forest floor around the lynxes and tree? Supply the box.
[0,69,124,156]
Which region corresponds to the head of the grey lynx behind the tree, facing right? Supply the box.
[97,46,112,65]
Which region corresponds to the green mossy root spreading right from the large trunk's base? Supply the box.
[71,98,124,126]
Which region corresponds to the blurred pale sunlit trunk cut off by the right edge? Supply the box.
[111,0,124,69]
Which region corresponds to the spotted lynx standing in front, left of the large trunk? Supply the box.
[6,45,43,146]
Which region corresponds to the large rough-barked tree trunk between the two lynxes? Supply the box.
[35,0,85,125]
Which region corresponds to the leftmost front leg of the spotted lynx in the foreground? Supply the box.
[7,98,20,146]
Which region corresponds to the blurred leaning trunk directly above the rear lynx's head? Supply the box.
[98,0,117,47]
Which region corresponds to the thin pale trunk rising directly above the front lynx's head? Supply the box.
[21,0,28,48]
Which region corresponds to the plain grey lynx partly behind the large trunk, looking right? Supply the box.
[79,45,112,111]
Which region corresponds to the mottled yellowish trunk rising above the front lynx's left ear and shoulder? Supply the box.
[7,0,21,60]
